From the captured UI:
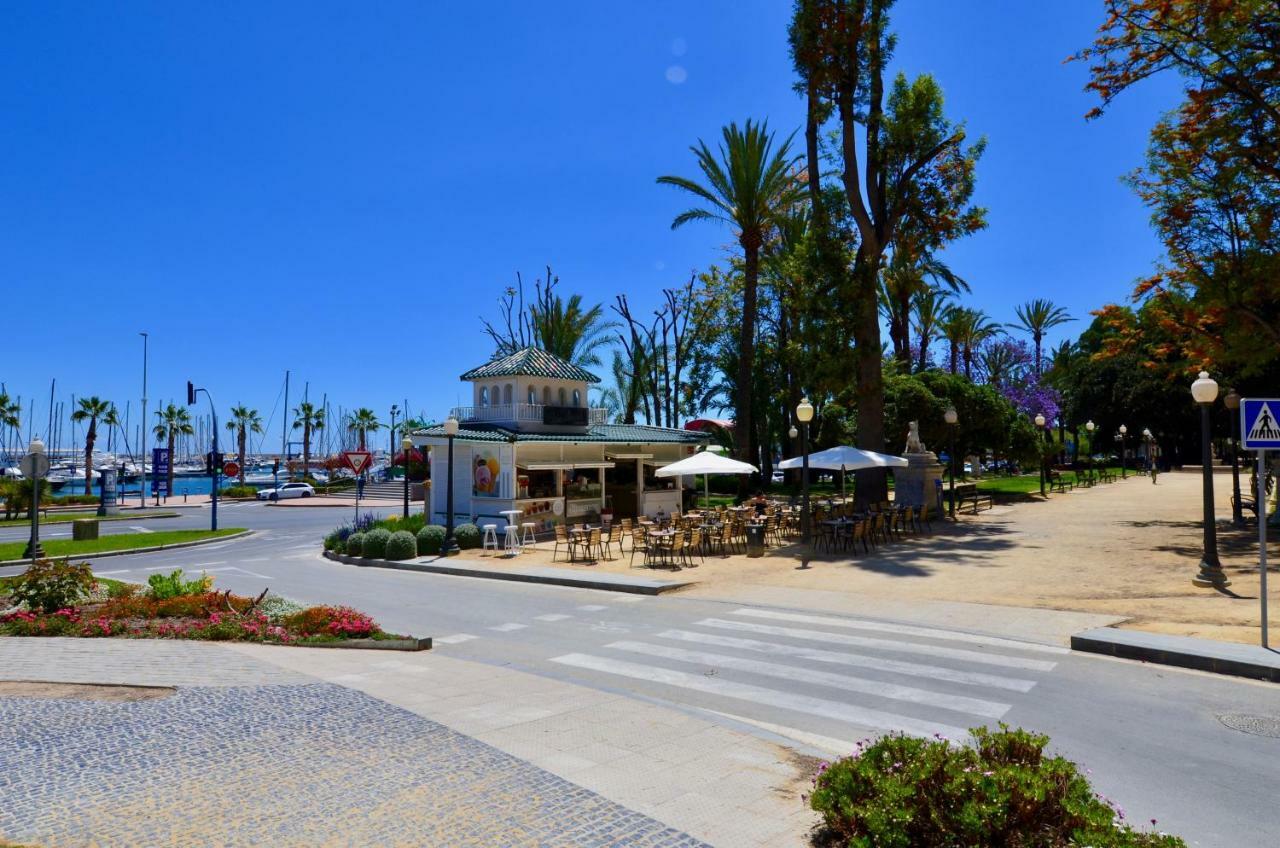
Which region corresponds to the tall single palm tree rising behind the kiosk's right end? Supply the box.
[658,120,803,479]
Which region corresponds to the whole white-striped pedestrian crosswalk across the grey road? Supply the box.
[552,607,1066,752]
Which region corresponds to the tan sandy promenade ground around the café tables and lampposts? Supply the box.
[490,469,1280,643]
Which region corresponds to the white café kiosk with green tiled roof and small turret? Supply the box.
[408,347,709,530]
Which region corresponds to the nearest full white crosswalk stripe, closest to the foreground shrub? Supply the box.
[552,653,969,740]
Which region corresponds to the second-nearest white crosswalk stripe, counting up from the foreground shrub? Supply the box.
[604,642,1011,719]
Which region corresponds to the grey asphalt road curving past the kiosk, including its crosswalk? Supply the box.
[0,503,1280,848]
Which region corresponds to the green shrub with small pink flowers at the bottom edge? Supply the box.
[809,724,1185,848]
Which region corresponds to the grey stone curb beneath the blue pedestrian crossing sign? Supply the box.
[1071,628,1280,683]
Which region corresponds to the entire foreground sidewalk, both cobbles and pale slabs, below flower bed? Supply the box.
[0,638,812,848]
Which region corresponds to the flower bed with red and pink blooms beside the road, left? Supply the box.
[0,560,416,644]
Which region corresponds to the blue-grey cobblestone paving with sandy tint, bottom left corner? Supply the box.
[0,686,704,848]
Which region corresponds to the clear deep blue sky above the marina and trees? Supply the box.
[0,0,1176,456]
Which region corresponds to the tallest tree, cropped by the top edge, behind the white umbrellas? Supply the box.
[790,0,984,501]
